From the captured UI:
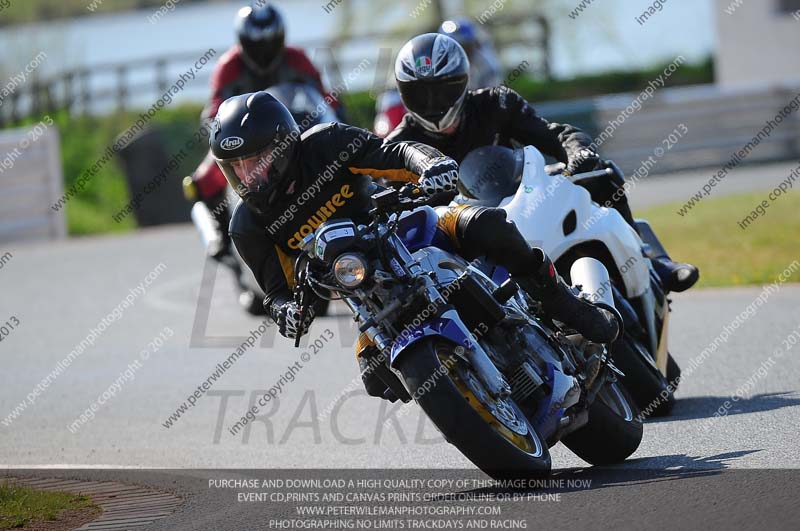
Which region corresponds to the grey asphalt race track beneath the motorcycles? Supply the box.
[0,165,800,529]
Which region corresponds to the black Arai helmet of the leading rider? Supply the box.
[211,92,300,214]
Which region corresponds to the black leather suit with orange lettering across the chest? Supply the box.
[225,124,544,314]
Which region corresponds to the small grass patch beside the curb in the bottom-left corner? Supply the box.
[0,481,99,529]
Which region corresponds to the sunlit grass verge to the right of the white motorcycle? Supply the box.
[636,191,800,287]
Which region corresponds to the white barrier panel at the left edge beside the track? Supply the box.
[0,124,66,243]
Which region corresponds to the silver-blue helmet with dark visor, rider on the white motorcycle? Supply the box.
[394,33,469,133]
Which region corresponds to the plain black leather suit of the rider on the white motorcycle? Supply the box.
[386,87,633,224]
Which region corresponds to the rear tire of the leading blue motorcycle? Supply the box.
[562,382,643,465]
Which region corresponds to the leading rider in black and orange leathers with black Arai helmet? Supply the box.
[210,92,620,372]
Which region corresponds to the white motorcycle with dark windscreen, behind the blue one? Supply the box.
[454,146,680,416]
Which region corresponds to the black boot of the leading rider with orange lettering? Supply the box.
[514,256,621,343]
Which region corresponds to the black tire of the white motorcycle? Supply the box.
[613,337,677,417]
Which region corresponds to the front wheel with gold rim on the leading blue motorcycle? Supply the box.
[397,338,550,478]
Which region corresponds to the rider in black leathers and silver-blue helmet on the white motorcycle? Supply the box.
[386,33,699,291]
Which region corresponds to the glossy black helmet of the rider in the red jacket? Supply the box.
[236,2,286,74]
